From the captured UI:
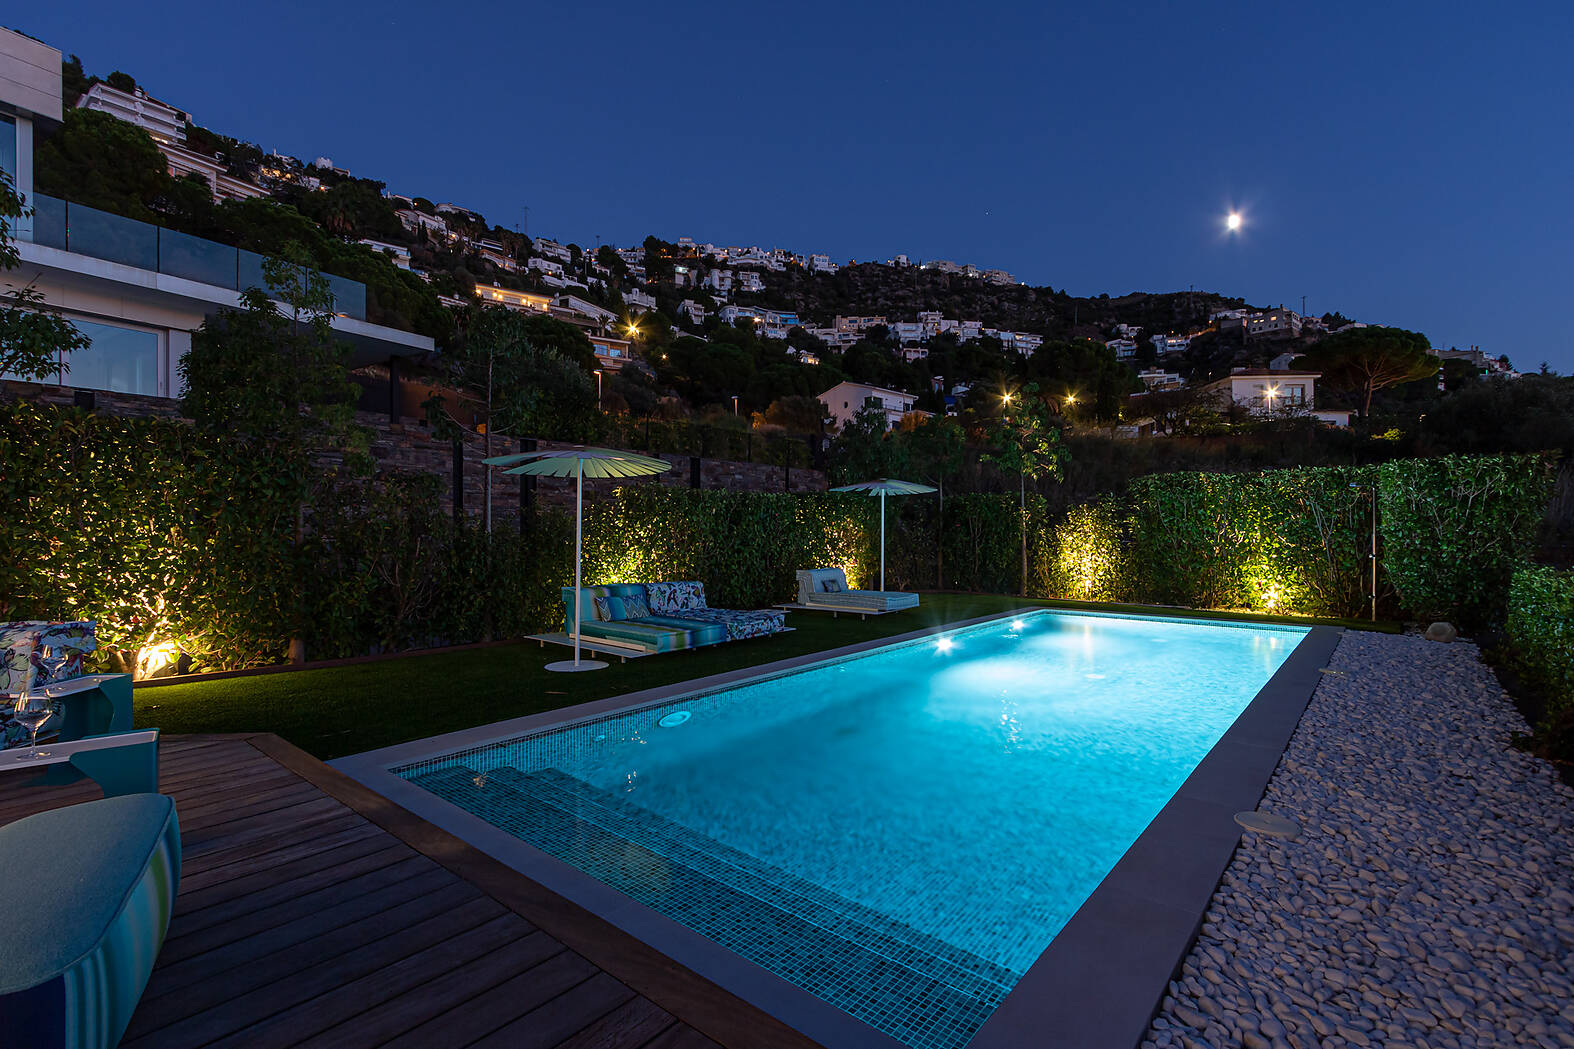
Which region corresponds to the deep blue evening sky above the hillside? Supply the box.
[13,0,1574,366]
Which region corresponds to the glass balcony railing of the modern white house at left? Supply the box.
[30,194,367,320]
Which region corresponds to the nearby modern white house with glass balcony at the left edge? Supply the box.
[0,30,434,413]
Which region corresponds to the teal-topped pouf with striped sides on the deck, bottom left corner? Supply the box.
[0,794,181,1049]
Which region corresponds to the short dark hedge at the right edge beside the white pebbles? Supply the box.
[1505,565,1574,725]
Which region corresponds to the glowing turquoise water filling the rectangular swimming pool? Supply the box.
[394,611,1305,1049]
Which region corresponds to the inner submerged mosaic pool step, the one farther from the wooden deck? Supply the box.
[491,769,1020,995]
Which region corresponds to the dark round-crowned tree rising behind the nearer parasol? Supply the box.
[427,306,595,532]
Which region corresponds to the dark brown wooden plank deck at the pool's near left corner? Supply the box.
[0,736,812,1049]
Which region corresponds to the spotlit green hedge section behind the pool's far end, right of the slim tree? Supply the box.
[1036,455,1552,624]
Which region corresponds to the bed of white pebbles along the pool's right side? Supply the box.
[1143,632,1574,1049]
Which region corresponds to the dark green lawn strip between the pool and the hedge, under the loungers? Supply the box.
[134,594,1388,761]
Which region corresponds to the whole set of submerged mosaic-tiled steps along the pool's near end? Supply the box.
[417,767,1015,1049]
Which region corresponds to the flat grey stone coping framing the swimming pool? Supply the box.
[329,606,1343,1049]
